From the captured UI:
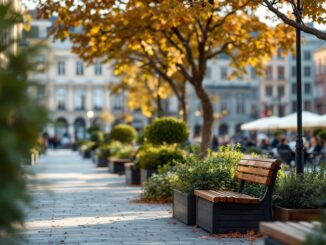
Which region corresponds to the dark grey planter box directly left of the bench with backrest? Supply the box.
[173,190,196,225]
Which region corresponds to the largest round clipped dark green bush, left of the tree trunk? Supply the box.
[145,117,189,145]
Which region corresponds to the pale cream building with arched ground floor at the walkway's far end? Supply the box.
[23,13,147,140]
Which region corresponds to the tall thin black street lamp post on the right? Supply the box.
[295,0,304,175]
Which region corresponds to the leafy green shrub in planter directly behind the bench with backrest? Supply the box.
[175,146,243,194]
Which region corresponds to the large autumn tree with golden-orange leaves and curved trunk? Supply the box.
[39,0,294,152]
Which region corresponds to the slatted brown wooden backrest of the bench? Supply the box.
[235,159,281,186]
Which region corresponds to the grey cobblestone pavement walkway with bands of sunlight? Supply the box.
[22,150,262,245]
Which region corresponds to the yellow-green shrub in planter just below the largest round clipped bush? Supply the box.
[137,145,185,169]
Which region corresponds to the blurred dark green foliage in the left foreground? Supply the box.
[0,1,47,237]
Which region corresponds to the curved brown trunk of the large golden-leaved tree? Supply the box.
[195,83,214,155]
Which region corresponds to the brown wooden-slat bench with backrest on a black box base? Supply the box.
[194,158,281,234]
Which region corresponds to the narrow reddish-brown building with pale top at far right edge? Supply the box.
[313,46,326,114]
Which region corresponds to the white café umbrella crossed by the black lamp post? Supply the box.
[277,111,321,129]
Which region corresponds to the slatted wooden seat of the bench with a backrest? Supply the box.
[194,190,259,204]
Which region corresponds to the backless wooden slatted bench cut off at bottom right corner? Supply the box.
[259,221,321,245]
